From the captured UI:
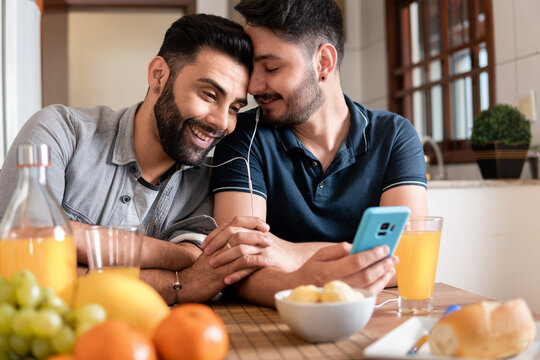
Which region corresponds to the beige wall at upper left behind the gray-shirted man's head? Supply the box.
[43,9,182,109]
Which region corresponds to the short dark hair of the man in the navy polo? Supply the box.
[235,0,344,67]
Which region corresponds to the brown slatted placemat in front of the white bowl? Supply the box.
[212,303,373,360]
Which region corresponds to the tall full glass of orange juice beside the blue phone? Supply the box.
[395,216,443,314]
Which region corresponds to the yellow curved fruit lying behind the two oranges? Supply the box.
[73,272,170,337]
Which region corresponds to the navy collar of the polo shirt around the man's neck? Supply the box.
[276,94,368,155]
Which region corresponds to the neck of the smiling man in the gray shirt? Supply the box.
[133,102,174,184]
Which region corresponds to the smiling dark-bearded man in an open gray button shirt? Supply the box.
[0,15,268,304]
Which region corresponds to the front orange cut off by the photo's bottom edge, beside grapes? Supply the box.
[75,320,157,360]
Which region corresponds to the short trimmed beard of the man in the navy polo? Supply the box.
[255,68,324,127]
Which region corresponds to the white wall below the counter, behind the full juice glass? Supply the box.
[428,180,540,313]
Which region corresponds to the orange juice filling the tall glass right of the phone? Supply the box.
[395,231,441,300]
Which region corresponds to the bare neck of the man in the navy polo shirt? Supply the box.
[293,86,350,171]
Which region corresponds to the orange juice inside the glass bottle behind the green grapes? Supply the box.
[0,236,77,304]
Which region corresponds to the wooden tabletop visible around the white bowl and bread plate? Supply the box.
[212,283,540,360]
